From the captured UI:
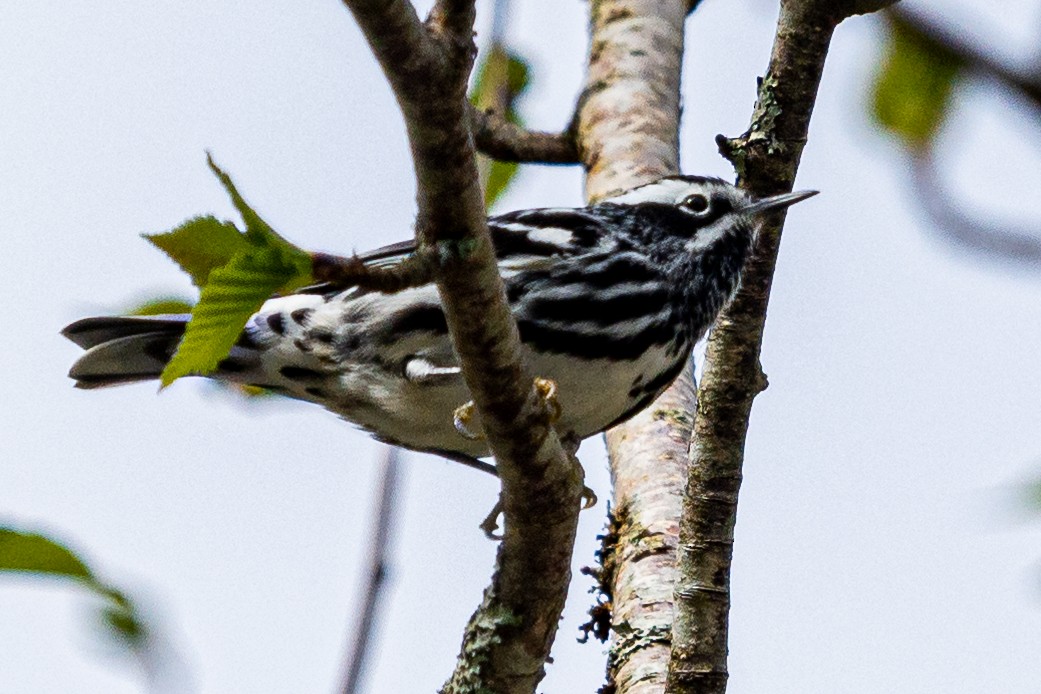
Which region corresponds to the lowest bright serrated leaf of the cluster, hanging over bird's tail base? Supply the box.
[160,248,299,387]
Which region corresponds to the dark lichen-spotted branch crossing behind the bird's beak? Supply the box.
[666,0,864,694]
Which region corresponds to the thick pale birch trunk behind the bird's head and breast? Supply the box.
[577,0,694,694]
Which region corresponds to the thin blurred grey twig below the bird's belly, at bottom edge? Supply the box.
[340,446,401,694]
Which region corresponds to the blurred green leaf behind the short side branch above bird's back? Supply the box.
[469,44,530,208]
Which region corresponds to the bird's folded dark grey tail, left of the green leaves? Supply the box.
[61,314,188,388]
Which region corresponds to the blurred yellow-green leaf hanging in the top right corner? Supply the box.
[872,20,964,152]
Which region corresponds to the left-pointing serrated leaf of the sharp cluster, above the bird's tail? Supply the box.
[143,215,249,287]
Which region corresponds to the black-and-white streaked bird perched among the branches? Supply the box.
[64,176,813,457]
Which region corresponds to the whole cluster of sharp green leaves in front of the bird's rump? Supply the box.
[157,154,313,388]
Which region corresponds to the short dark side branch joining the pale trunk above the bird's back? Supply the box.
[468,106,579,164]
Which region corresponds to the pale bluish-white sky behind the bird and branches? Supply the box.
[0,0,1041,694]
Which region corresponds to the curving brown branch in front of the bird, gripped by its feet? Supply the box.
[345,0,583,694]
